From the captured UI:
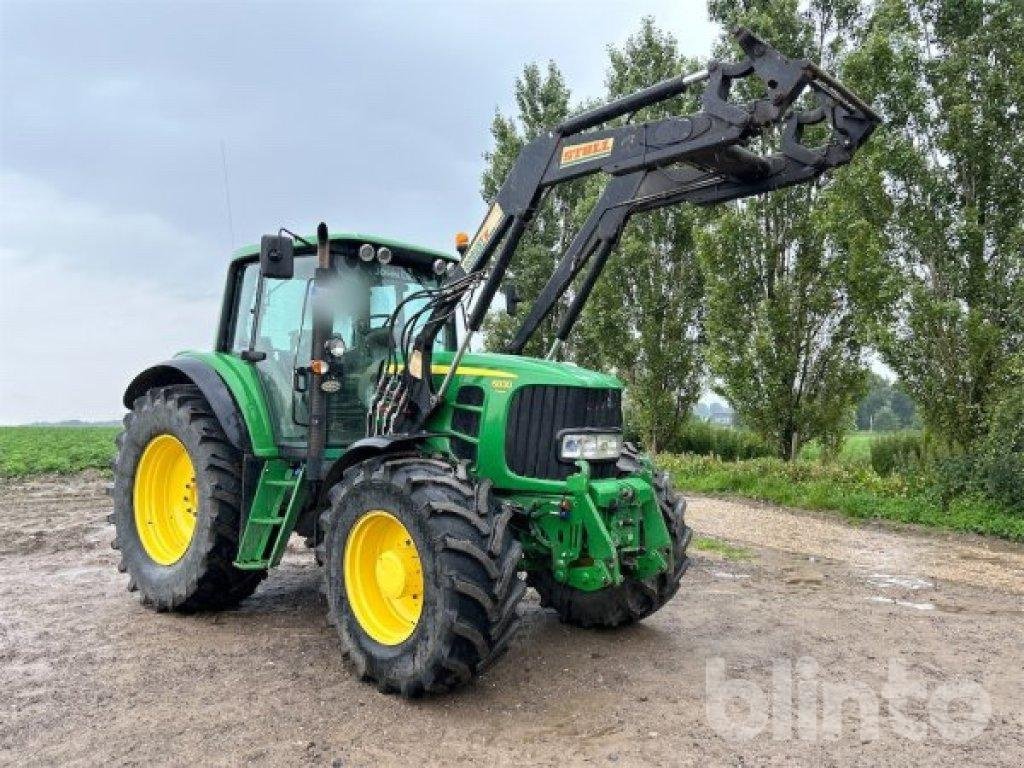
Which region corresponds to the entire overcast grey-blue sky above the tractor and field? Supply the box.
[0,0,716,424]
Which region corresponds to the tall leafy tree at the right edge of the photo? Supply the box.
[846,0,1024,450]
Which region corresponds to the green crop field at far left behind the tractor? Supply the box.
[0,427,119,477]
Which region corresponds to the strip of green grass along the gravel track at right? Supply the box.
[657,455,1024,541]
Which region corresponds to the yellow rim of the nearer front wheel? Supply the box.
[343,509,423,645]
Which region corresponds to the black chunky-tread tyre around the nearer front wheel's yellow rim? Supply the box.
[319,456,525,697]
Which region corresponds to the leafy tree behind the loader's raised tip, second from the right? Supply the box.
[698,0,892,459]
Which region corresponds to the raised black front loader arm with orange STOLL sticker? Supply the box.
[368,30,879,434]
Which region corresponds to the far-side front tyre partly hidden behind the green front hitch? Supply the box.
[527,443,692,628]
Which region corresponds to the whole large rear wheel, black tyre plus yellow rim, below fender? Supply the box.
[110,385,266,611]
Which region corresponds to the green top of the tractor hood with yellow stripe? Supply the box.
[431,351,623,389]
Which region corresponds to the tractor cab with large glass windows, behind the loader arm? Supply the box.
[217,233,456,451]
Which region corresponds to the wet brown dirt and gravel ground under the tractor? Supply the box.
[0,475,1024,766]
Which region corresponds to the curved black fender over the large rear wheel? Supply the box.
[123,357,252,453]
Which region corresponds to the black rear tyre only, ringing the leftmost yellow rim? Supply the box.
[110,385,266,611]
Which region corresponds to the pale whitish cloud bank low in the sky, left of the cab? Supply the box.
[0,174,225,424]
